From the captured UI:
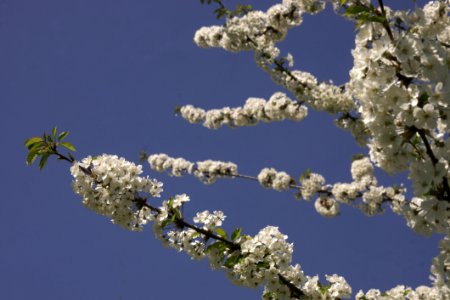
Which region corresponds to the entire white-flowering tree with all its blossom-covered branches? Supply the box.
[25,0,450,299]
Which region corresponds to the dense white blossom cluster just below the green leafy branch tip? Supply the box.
[70,154,162,231]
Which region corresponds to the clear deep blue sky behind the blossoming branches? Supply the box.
[0,0,438,300]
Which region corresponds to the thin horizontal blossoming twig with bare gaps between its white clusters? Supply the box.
[147,153,450,235]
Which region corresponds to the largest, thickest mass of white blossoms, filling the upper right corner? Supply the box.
[348,1,450,179]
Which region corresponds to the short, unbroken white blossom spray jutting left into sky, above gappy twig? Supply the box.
[179,92,308,129]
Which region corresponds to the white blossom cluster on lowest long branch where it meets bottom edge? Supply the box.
[228,226,352,299]
